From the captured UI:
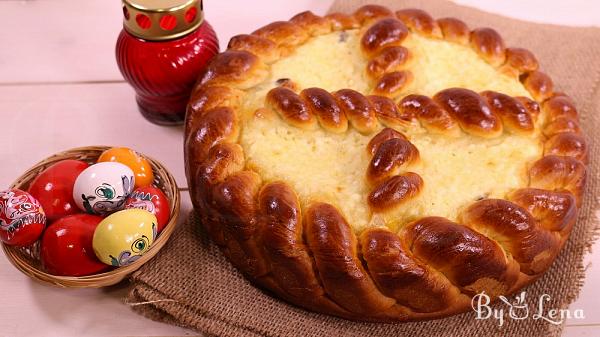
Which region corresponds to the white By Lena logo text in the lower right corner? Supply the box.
[471,291,585,326]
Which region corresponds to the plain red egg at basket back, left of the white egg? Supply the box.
[29,159,89,221]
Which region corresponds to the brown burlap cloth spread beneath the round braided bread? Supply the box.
[126,0,600,336]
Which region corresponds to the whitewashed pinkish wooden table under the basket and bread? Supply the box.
[0,0,600,337]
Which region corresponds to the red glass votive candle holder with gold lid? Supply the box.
[116,0,219,125]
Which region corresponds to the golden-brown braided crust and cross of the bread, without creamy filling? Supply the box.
[185,5,587,321]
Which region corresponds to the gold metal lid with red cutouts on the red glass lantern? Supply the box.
[123,0,204,41]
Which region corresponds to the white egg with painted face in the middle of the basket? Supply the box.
[73,162,135,215]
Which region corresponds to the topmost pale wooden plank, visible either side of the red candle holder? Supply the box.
[0,0,332,83]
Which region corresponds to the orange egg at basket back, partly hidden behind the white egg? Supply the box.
[98,147,154,188]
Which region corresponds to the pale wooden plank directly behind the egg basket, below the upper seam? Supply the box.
[0,83,186,187]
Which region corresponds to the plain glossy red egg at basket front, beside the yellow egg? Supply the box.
[40,214,110,276]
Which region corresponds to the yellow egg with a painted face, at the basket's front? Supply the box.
[92,208,157,266]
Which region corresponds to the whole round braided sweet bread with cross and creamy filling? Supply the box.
[185,5,587,321]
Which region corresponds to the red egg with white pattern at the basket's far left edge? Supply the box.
[0,188,46,247]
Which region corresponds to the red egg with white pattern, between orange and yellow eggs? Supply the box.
[125,186,171,233]
